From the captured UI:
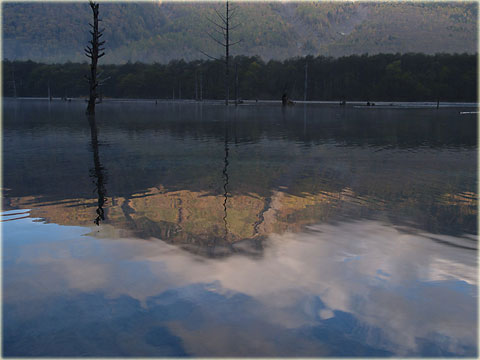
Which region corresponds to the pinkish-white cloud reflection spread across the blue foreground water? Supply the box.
[5,221,477,355]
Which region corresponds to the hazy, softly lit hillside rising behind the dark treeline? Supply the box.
[2,1,478,63]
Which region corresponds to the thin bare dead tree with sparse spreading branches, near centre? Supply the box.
[200,0,242,105]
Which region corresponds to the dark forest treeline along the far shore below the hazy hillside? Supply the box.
[3,54,477,101]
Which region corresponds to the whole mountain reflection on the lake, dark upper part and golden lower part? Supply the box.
[3,101,477,246]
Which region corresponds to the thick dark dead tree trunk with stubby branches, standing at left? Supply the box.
[84,0,105,115]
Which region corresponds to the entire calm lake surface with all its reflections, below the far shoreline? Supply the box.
[2,99,478,357]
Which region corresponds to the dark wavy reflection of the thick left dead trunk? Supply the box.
[88,115,107,225]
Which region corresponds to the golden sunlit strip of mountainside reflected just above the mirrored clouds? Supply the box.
[10,186,477,246]
